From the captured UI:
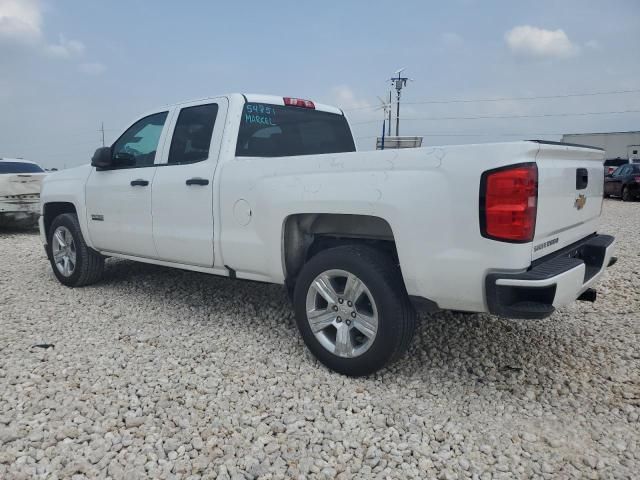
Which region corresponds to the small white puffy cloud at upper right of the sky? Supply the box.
[504,25,580,58]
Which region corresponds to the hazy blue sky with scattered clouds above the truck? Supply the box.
[0,0,640,168]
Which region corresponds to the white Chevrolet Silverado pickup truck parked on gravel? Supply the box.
[40,94,615,376]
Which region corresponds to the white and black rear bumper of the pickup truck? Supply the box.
[485,235,615,319]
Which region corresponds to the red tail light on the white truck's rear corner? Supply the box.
[480,163,538,243]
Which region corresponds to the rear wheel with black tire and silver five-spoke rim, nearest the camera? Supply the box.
[294,245,416,377]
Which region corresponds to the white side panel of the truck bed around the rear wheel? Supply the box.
[220,142,538,311]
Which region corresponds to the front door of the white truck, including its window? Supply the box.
[86,111,169,258]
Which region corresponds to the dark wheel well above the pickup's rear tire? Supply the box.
[282,213,398,285]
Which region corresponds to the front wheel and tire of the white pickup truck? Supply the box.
[47,213,104,287]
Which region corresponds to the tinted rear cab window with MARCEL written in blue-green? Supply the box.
[236,103,356,157]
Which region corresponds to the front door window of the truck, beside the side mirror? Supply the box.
[111,112,168,168]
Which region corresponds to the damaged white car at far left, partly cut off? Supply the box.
[0,158,47,228]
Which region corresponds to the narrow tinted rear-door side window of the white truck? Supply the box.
[169,103,218,164]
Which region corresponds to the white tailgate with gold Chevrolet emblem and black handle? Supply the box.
[532,142,604,260]
